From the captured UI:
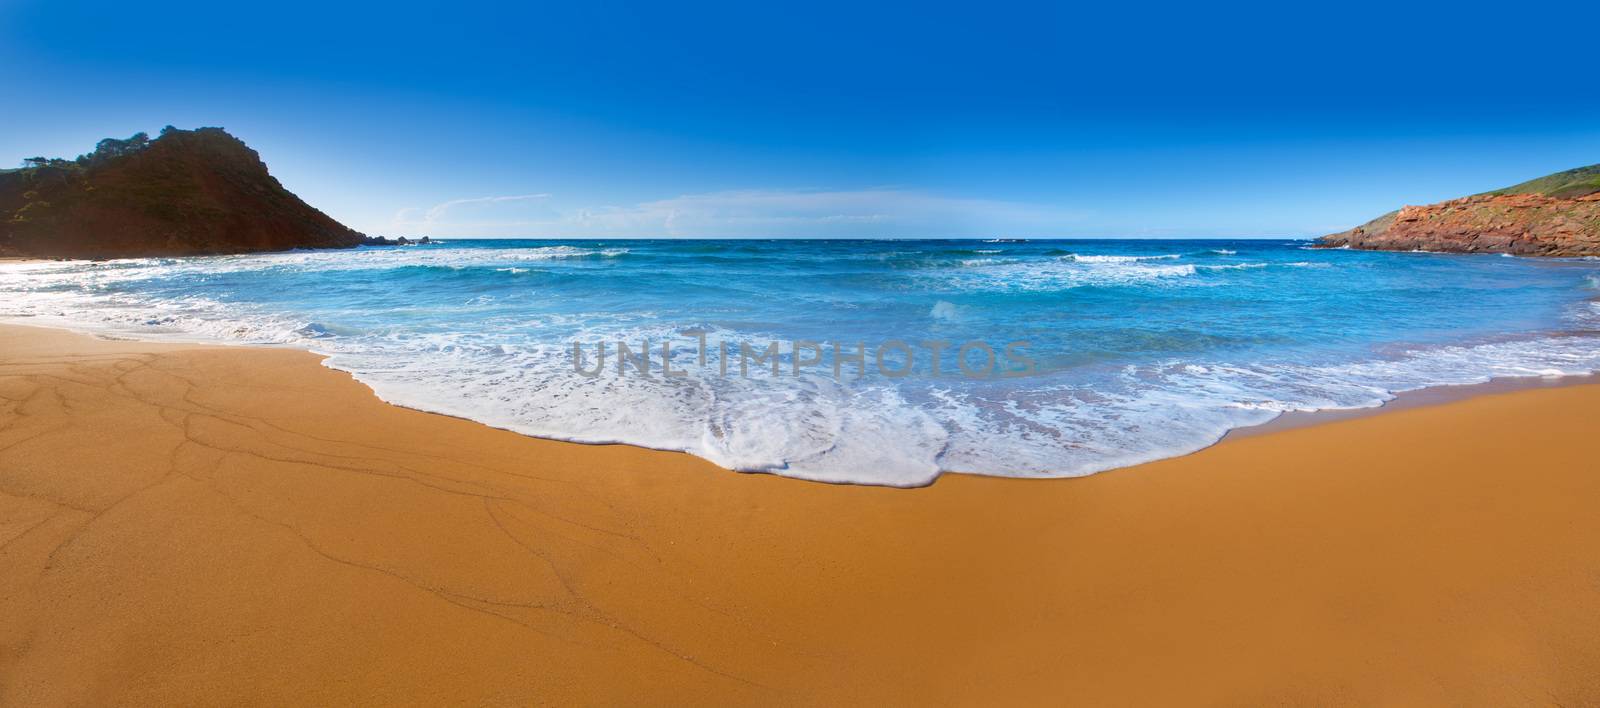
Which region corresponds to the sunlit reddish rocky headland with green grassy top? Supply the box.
[1317,165,1600,256]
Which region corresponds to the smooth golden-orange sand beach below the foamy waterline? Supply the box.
[0,327,1600,706]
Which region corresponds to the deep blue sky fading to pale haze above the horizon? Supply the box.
[0,0,1600,237]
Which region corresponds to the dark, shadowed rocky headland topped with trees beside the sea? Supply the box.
[0,127,365,258]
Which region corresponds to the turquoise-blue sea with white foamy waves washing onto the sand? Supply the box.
[0,240,1600,485]
